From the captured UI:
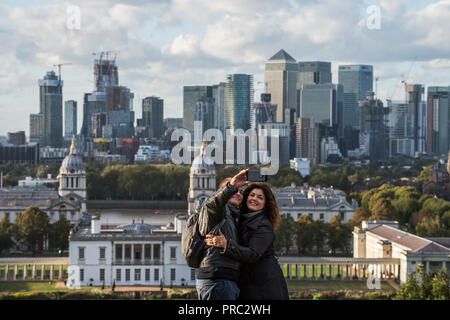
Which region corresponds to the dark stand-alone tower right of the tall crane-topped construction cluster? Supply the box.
[142,96,164,139]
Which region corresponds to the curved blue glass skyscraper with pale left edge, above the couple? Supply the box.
[226,74,254,131]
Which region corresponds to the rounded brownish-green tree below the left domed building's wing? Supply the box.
[14,206,49,250]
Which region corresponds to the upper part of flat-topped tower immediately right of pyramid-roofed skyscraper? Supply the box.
[297,61,331,89]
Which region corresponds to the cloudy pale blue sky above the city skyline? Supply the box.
[0,0,450,135]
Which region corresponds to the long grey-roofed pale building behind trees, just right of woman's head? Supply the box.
[273,185,358,223]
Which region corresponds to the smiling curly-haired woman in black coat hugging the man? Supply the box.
[205,182,289,300]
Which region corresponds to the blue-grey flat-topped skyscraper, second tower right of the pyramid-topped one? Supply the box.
[339,65,373,129]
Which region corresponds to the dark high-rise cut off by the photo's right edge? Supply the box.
[426,86,450,155]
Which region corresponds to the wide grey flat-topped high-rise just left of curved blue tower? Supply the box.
[183,86,213,132]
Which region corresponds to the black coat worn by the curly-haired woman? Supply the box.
[224,212,289,300]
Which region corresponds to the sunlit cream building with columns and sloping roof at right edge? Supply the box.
[353,221,450,283]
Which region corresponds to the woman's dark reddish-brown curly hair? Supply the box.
[241,182,281,230]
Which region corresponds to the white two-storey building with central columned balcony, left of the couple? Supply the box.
[67,214,195,287]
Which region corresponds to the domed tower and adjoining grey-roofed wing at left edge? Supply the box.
[0,138,87,224]
